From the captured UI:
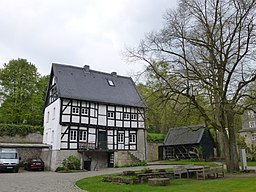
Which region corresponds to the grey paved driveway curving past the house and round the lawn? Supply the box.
[0,165,175,192]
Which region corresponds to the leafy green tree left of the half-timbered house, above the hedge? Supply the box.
[0,59,47,125]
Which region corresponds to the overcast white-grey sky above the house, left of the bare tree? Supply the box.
[0,0,177,75]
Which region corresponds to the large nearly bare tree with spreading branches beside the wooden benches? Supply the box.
[128,0,256,172]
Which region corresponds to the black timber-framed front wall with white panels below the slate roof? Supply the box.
[59,98,144,151]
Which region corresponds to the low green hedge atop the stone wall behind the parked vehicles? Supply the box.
[0,124,44,136]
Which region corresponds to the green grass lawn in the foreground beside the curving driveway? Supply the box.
[76,176,256,192]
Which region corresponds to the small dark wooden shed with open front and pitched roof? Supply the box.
[158,125,215,160]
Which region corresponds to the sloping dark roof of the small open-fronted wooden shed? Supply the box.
[164,125,206,145]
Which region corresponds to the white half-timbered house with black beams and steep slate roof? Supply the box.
[42,64,146,170]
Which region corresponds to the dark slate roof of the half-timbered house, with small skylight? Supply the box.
[52,63,146,107]
